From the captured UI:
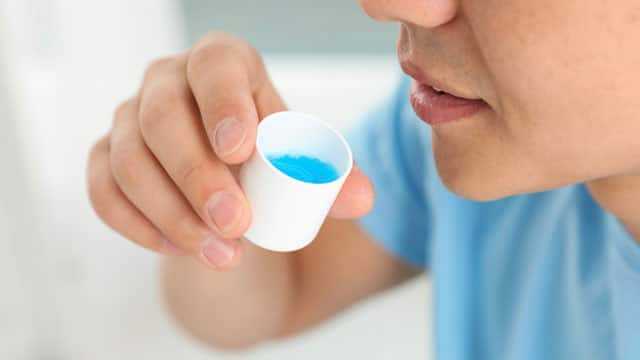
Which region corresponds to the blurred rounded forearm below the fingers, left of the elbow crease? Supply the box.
[163,242,294,348]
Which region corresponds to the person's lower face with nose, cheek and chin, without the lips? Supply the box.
[361,0,640,200]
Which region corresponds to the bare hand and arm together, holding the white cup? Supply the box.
[88,33,418,348]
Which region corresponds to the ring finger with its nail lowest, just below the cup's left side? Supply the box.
[110,101,240,269]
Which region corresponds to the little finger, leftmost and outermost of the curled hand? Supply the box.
[87,138,184,255]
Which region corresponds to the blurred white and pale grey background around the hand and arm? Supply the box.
[0,0,431,360]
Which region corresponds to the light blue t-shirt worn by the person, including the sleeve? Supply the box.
[350,79,640,360]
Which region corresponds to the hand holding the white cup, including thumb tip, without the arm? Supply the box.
[88,33,374,270]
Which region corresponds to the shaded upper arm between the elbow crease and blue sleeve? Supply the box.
[280,219,420,336]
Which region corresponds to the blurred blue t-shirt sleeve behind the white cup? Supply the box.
[348,79,431,268]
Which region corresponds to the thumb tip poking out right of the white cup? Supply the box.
[329,164,375,219]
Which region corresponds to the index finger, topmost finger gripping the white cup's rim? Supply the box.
[187,34,284,164]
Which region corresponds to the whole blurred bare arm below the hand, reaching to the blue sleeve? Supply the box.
[164,219,419,348]
